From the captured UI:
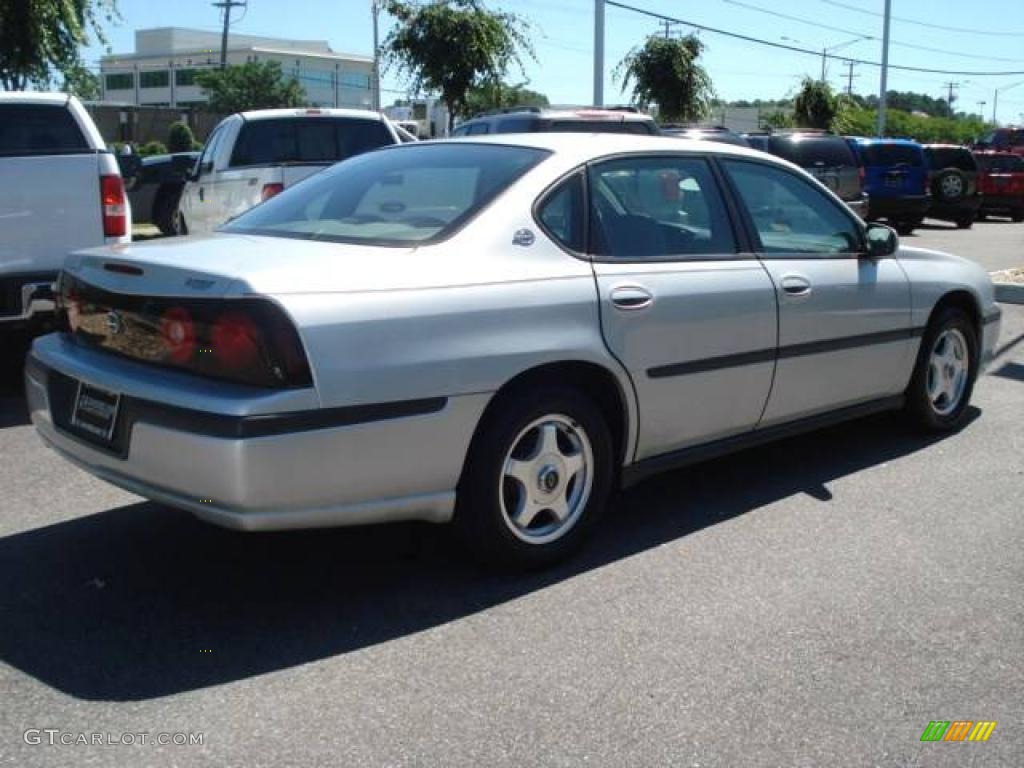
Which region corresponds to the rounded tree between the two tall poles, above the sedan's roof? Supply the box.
[614,35,715,123]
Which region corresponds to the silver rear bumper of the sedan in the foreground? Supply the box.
[25,335,488,530]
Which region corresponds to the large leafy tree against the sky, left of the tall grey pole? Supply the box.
[383,0,536,128]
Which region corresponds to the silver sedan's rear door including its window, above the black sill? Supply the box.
[587,153,776,460]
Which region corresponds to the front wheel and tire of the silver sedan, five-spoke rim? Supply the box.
[904,307,978,432]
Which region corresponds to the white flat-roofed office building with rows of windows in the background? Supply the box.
[99,27,373,109]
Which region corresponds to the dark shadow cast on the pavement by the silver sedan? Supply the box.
[0,409,980,700]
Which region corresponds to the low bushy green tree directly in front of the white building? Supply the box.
[196,61,306,113]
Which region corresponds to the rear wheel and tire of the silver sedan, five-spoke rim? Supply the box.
[455,386,613,568]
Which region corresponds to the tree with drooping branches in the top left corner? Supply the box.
[0,0,119,91]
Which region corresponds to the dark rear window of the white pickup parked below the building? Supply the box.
[230,117,394,167]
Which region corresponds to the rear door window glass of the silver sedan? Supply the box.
[588,156,736,260]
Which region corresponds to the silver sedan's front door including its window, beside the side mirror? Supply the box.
[722,159,916,426]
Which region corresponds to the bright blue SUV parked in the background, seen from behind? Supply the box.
[847,137,932,234]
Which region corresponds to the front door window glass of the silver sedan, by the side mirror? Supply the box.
[722,160,862,256]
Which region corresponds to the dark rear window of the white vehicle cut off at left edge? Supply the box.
[0,104,89,157]
